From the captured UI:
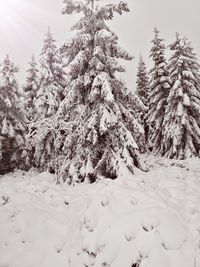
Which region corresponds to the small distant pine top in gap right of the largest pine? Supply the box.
[136,56,149,106]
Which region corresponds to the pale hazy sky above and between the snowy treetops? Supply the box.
[0,0,200,90]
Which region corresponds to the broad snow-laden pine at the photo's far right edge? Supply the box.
[161,34,200,159]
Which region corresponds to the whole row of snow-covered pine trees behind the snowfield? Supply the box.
[0,0,200,183]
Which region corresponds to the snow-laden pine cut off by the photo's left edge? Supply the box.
[0,56,27,173]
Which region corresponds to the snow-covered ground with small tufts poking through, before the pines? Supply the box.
[0,157,200,267]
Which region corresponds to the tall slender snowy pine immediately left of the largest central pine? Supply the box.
[29,29,66,170]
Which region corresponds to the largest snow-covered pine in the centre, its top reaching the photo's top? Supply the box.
[59,0,148,183]
